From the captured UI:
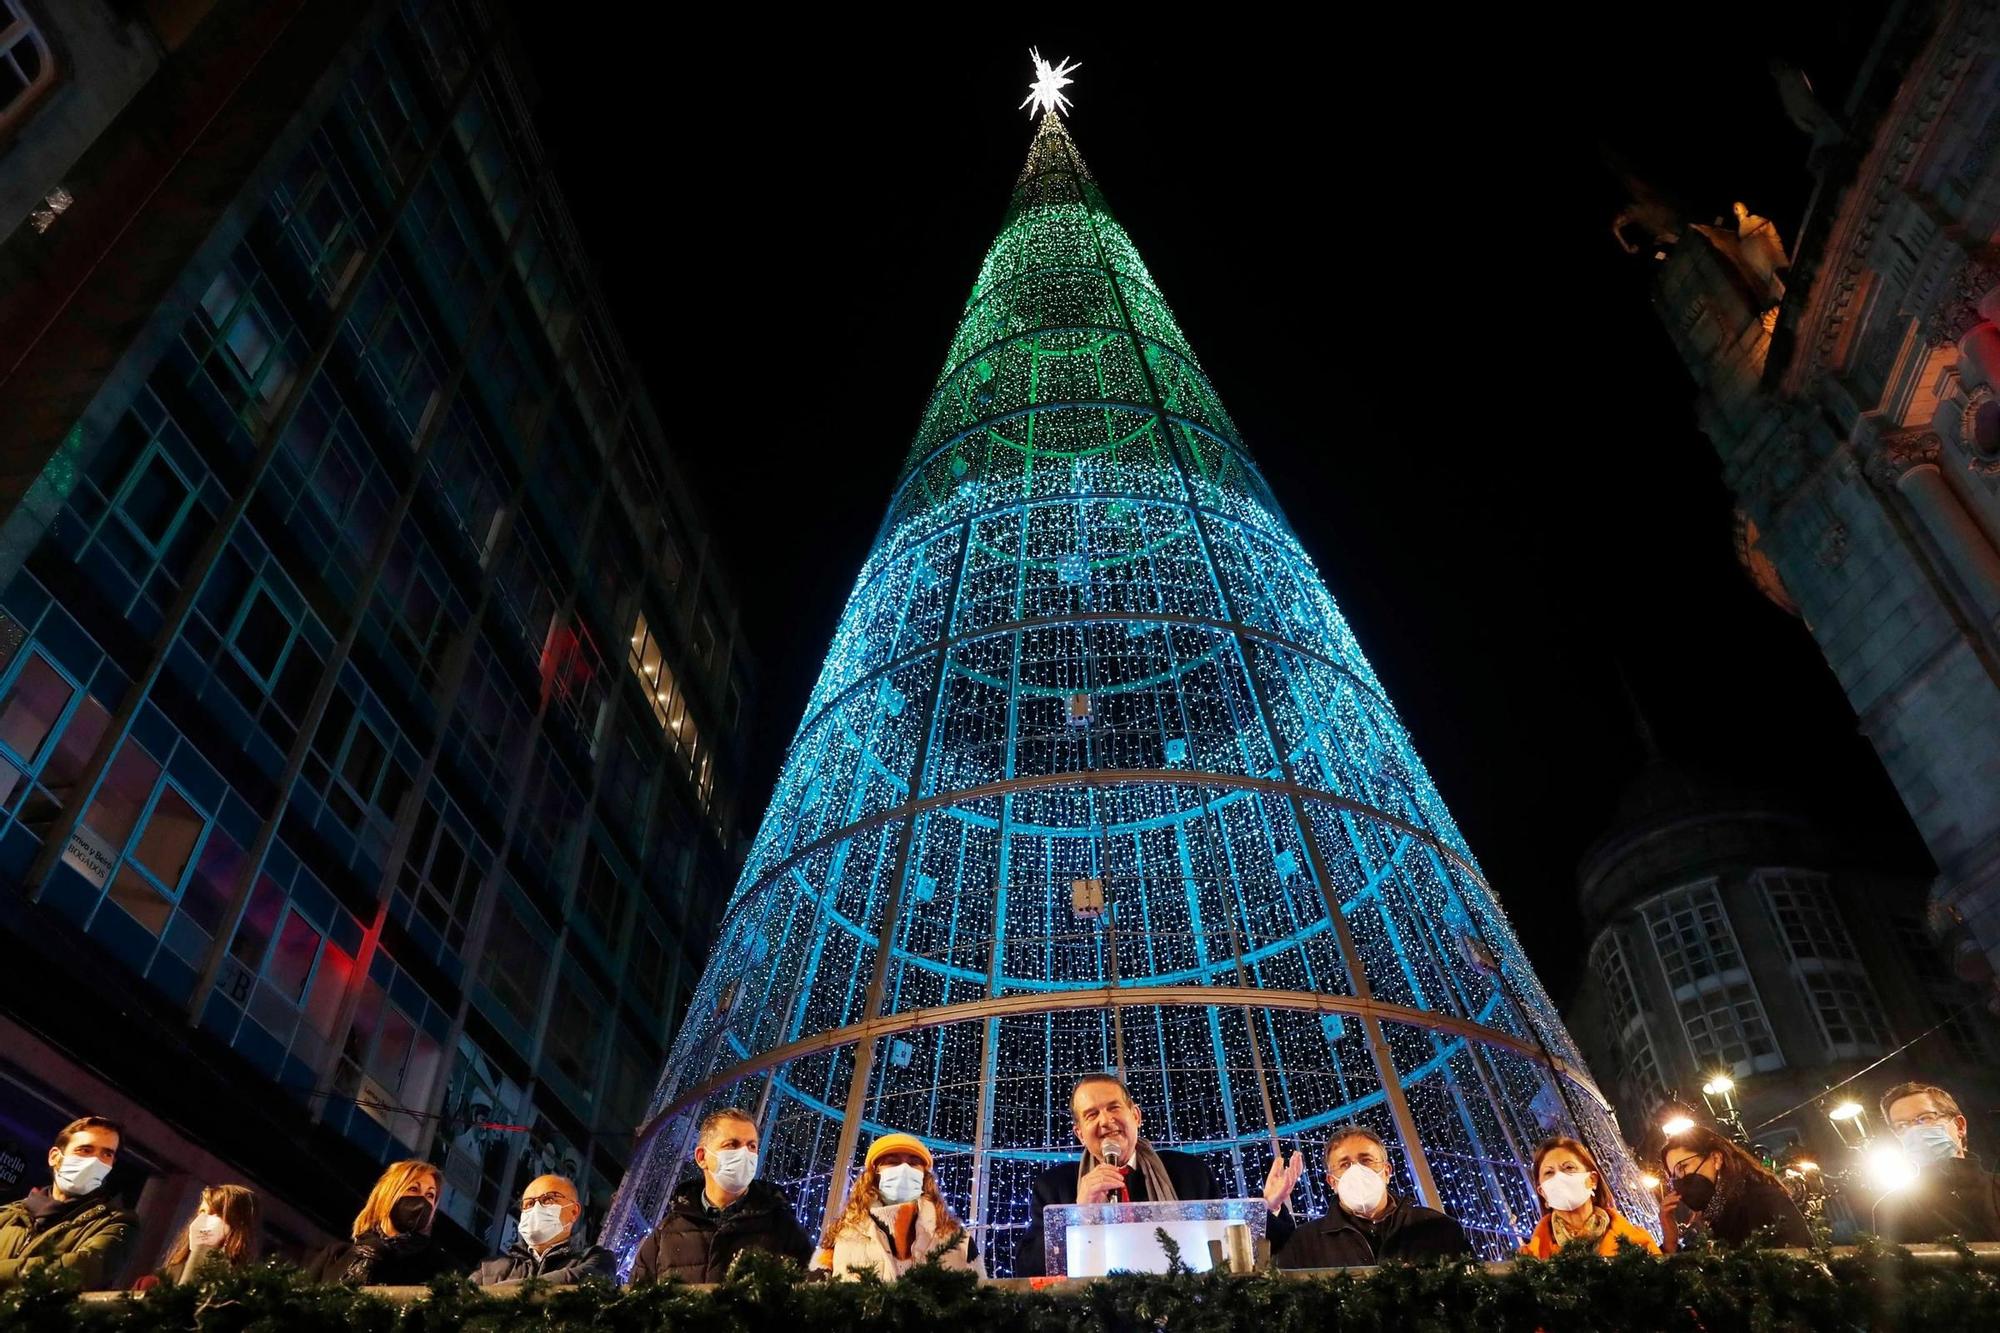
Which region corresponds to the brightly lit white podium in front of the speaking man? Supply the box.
[1042,1199,1270,1277]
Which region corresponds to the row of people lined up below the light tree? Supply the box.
[0,1075,2000,1289]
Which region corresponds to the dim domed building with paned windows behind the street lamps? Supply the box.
[1566,761,2000,1237]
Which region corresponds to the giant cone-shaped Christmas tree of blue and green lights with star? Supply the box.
[606,64,1654,1271]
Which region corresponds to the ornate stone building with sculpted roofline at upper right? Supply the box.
[1618,0,2000,985]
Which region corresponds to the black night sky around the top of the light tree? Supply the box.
[512,4,1928,997]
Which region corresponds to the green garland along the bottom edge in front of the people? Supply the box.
[15,1247,2000,1333]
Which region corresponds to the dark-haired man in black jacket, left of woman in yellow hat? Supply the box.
[632,1107,812,1287]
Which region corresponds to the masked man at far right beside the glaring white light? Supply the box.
[1874,1083,2000,1245]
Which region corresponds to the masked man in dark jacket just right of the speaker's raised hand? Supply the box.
[1272,1125,1472,1269]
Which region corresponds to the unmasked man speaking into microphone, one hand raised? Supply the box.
[1014,1073,1306,1277]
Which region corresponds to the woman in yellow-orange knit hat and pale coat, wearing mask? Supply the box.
[812,1135,976,1283]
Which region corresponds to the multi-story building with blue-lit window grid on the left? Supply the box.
[0,0,750,1261]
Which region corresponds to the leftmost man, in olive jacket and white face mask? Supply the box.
[0,1115,138,1291]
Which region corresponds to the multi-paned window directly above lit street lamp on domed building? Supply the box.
[1644,881,1784,1077]
